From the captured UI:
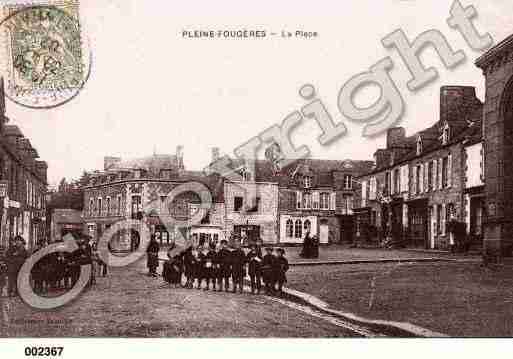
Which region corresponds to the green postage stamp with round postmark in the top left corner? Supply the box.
[0,5,91,108]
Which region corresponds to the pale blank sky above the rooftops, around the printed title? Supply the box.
[1,0,513,183]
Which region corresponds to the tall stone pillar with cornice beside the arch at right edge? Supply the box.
[476,35,513,258]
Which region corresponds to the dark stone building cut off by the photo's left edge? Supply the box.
[0,80,48,249]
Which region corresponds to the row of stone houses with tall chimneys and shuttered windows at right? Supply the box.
[356,86,482,249]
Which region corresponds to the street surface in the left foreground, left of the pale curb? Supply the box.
[0,261,355,337]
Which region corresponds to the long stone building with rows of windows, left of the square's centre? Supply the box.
[83,146,224,251]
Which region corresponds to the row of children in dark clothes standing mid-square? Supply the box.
[162,240,289,295]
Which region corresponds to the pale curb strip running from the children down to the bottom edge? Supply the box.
[283,288,449,338]
